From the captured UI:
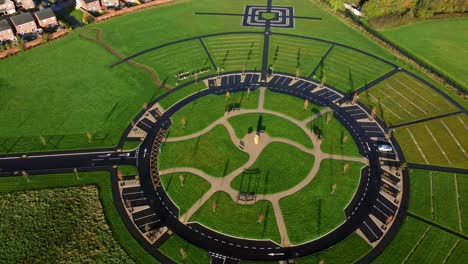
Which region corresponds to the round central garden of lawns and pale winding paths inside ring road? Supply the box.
[158,84,366,245]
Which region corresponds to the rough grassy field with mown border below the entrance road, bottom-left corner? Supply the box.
[0,172,158,263]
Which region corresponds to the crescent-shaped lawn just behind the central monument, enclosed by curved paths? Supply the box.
[228,114,313,148]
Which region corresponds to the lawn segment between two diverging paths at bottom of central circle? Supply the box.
[190,192,281,243]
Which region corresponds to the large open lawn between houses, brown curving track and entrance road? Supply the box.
[0,32,163,153]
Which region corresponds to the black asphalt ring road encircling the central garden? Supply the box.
[134,75,380,260]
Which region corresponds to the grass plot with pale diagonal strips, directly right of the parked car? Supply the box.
[395,114,468,168]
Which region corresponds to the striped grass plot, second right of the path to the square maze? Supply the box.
[315,46,392,93]
